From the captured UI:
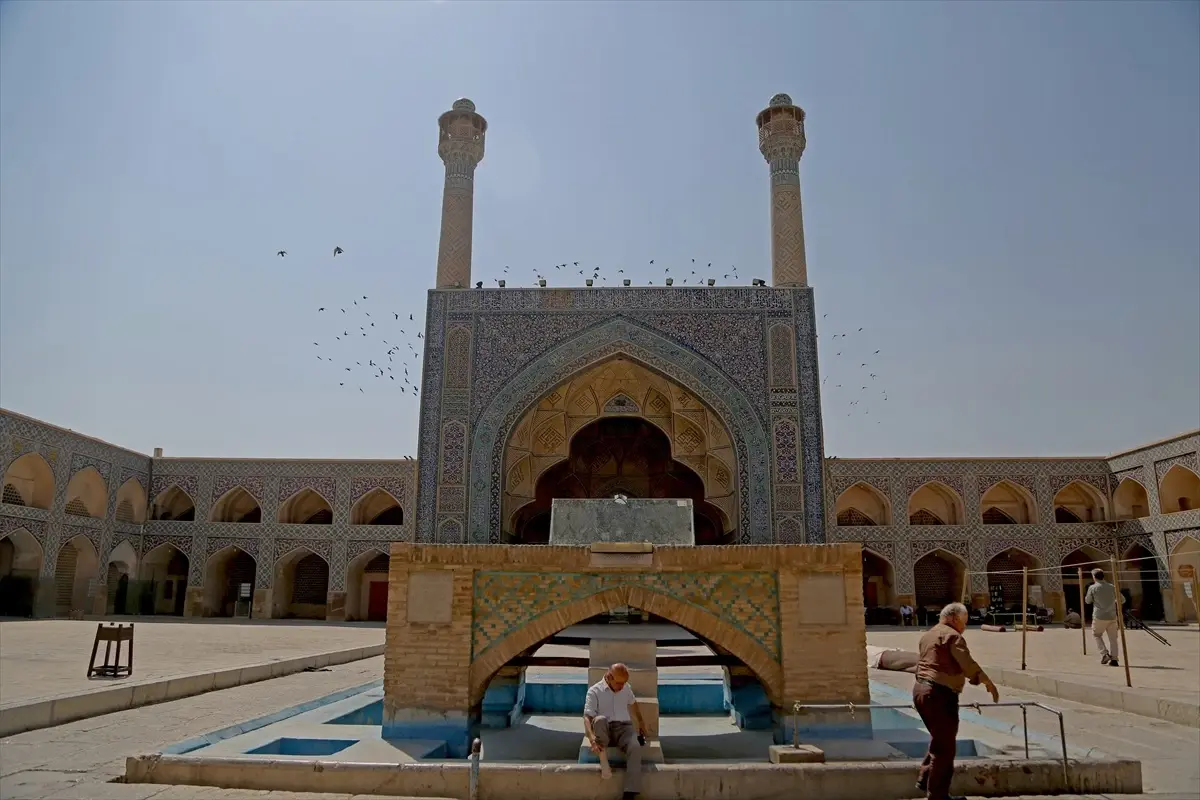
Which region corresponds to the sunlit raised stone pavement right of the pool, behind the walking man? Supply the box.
[866,625,1200,721]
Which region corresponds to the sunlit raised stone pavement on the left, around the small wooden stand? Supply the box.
[0,618,384,705]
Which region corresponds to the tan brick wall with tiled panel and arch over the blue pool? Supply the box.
[384,542,869,715]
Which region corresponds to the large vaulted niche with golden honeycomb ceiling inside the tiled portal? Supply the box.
[502,356,738,543]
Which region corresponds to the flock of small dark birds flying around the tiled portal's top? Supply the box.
[276,247,888,425]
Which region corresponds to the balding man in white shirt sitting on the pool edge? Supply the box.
[583,663,646,800]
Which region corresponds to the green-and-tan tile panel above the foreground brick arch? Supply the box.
[472,571,780,661]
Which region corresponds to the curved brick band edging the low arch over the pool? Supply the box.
[468,587,784,705]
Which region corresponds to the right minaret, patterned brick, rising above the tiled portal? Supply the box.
[757,95,809,287]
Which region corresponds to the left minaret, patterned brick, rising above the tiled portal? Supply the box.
[437,97,487,289]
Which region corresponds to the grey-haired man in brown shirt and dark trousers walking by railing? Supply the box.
[912,603,1000,800]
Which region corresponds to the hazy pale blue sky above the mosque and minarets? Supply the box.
[0,1,1200,458]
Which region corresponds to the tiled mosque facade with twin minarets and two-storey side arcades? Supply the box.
[0,95,1200,622]
